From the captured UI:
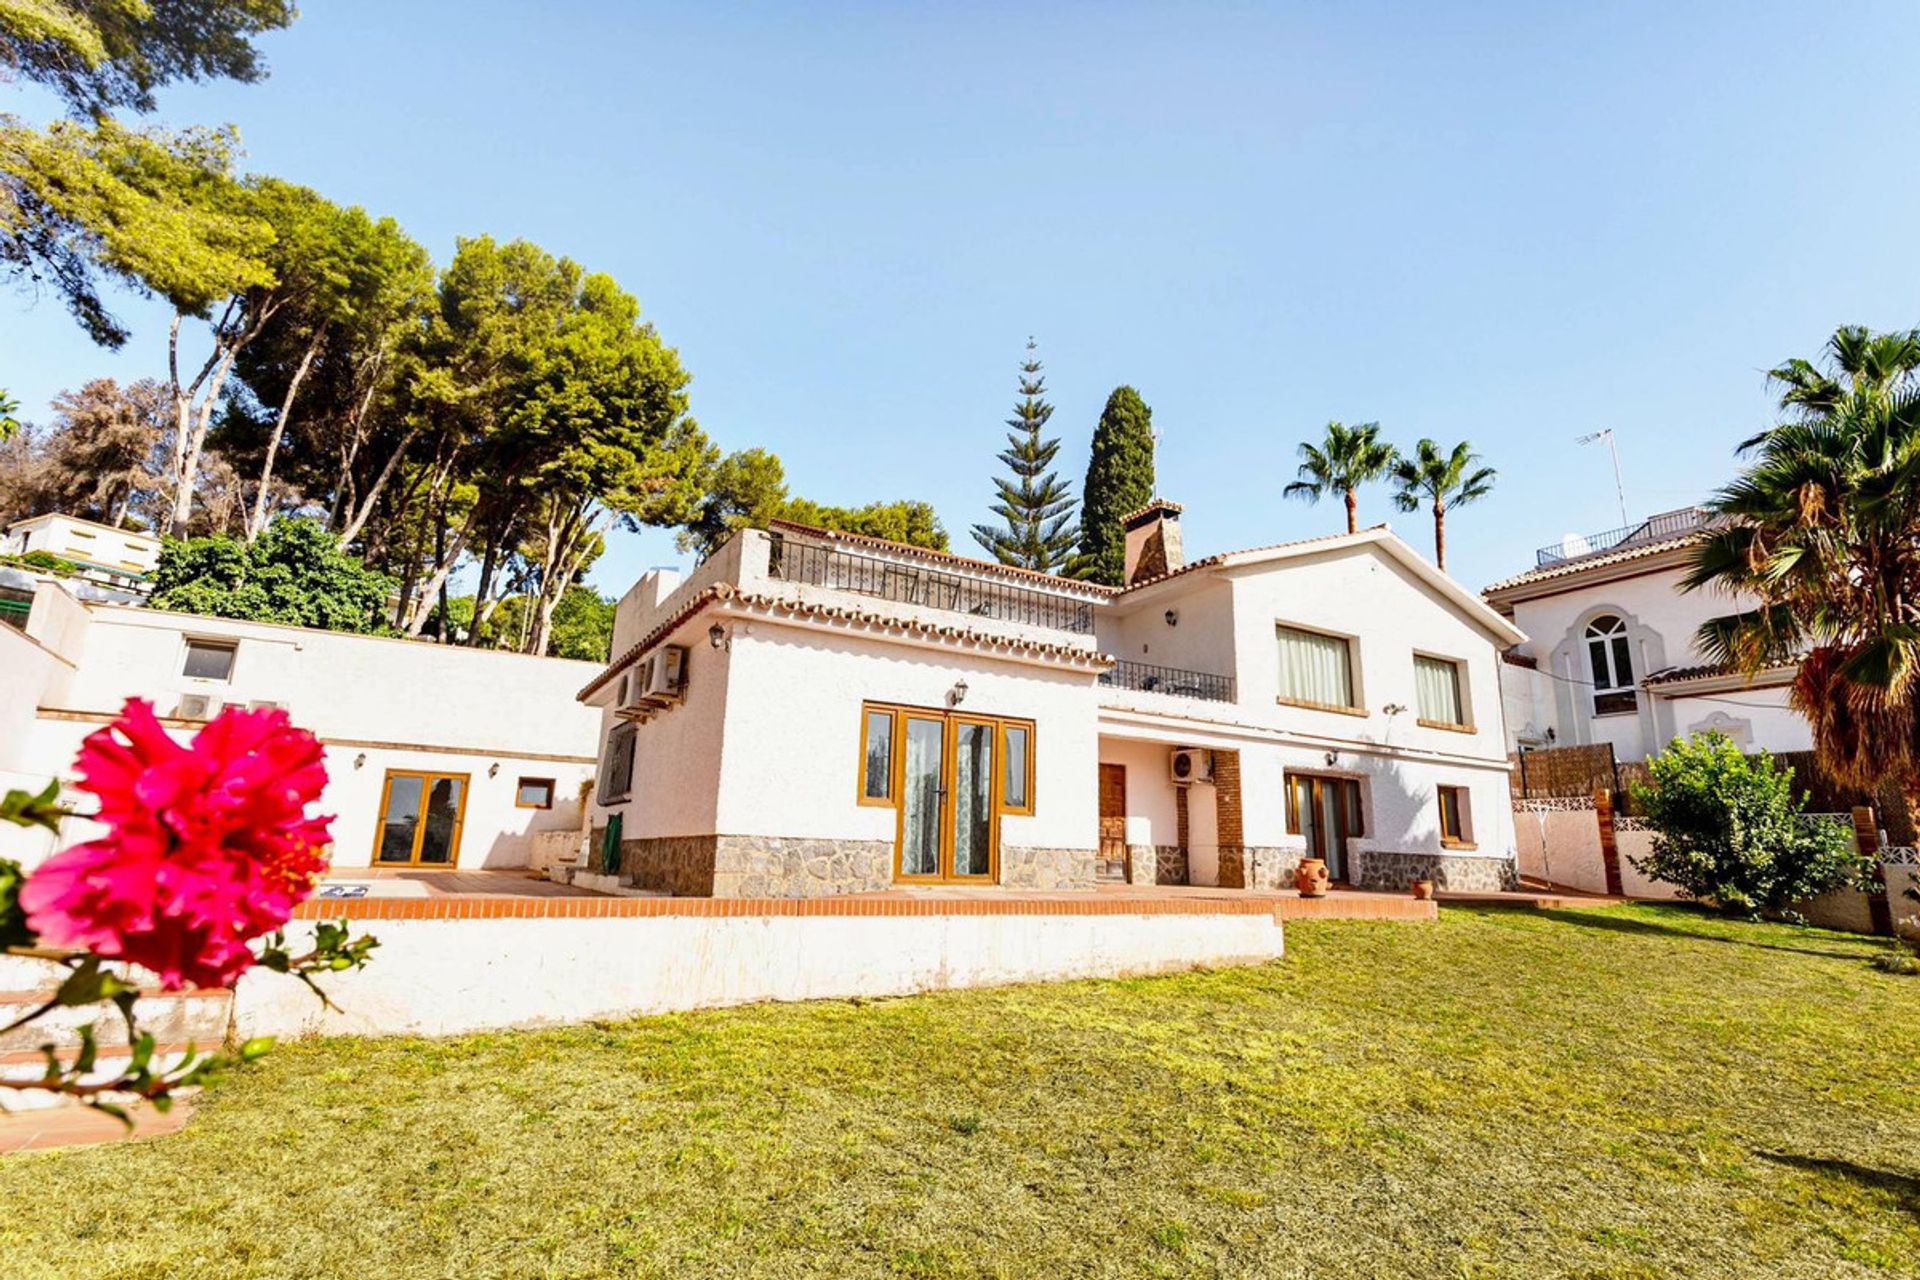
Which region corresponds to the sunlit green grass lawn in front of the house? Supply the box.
[0,906,1920,1280]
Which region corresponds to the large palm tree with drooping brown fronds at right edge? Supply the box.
[1686,328,1920,802]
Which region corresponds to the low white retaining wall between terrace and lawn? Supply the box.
[234,912,1284,1036]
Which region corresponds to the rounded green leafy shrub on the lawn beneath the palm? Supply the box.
[1628,733,1868,917]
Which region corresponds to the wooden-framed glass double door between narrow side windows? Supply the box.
[893,710,1000,885]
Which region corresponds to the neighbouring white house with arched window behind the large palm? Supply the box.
[1484,507,1812,760]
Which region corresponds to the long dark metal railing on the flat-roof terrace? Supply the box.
[770,533,1092,635]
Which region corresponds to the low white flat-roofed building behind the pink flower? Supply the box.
[0,583,599,869]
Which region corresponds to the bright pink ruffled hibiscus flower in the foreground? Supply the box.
[19,699,332,990]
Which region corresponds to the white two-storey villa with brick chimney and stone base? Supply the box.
[580,501,1524,898]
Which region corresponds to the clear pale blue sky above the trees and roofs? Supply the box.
[0,0,1920,591]
